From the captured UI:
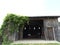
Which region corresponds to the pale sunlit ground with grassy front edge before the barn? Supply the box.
[11,40,60,45]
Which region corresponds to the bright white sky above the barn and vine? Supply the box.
[0,0,60,25]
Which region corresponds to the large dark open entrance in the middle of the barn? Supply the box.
[23,20,44,39]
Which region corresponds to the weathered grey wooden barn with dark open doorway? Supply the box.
[10,16,60,41]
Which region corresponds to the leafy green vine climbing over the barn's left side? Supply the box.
[0,14,29,45]
